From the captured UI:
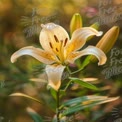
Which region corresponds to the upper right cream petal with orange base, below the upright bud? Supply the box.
[66,27,102,54]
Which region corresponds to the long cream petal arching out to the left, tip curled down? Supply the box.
[11,46,55,64]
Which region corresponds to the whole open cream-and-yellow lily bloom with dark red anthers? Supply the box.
[11,23,107,91]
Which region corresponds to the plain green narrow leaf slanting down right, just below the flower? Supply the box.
[69,77,98,90]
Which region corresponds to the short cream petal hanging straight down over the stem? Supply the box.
[45,65,65,91]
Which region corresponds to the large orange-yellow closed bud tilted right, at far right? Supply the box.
[96,26,119,53]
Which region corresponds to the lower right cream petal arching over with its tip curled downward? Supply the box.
[67,46,107,65]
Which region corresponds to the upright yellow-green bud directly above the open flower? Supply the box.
[70,13,82,35]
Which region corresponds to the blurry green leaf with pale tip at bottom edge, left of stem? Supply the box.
[26,107,44,122]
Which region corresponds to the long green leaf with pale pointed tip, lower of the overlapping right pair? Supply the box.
[62,96,119,116]
